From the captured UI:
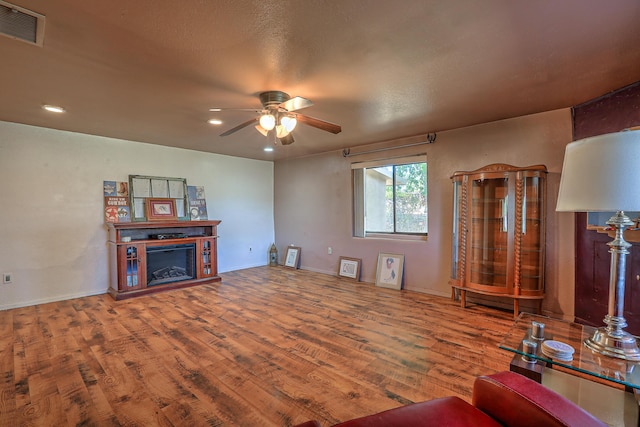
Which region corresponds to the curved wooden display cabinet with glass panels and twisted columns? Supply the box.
[450,164,547,317]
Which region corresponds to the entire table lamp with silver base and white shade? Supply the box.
[556,130,640,361]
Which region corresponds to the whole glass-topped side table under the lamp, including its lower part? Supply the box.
[499,313,640,427]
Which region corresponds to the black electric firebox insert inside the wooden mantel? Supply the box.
[147,243,196,286]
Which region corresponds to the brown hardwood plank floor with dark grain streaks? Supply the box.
[0,267,513,427]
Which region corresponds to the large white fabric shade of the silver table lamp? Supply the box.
[556,130,640,212]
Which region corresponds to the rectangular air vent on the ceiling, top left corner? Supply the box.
[0,0,44,47]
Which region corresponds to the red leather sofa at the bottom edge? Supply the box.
[296,371,606,427]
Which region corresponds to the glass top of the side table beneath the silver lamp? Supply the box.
[499,313,640,392]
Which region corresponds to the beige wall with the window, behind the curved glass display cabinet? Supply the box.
[274,109,574,317]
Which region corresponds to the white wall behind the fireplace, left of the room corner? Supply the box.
[0,122,274,309]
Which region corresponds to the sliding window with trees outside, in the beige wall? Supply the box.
[352,155,427,237]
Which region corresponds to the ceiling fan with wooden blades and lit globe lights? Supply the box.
[209,90,342,145]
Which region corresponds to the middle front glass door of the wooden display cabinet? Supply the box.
[469,178,510,288]
